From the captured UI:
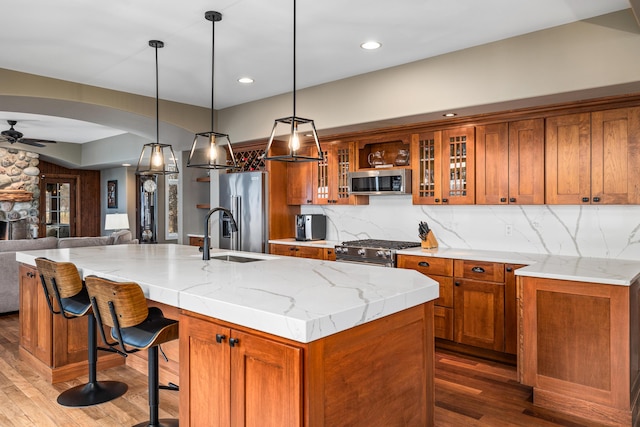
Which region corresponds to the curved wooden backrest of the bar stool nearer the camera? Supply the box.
[85,276,149,328]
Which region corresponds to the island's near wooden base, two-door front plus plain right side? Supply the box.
[180,302,435,427]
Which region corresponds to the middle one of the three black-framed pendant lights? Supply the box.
[187,11,238,169]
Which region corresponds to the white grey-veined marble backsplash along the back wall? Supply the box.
[301,196,640,261]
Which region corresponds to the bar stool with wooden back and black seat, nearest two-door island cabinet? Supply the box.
[85,276,178,427]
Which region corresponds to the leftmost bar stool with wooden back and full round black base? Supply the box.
[36,258,128,407]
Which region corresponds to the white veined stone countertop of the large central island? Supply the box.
[16,244,439,343]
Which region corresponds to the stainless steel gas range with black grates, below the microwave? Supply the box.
[335,239,420,267]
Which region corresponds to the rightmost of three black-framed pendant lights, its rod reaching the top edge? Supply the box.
[263,0,324,162]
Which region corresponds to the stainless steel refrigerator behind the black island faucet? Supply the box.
[219,172,269,253]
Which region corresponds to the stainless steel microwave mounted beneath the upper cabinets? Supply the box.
[347,168,411,195]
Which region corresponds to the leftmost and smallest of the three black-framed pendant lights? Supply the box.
[136,40,178,175]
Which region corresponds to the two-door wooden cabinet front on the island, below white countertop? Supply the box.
[180,315,302,426]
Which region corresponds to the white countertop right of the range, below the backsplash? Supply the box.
[397,248,640,286]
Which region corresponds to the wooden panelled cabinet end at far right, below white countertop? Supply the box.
[522,277,639,425]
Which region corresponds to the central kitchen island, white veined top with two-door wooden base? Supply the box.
[16,245,438,426]
